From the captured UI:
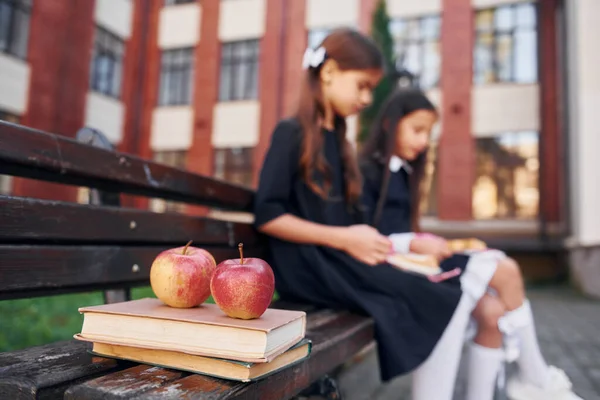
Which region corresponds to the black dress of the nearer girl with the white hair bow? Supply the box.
[255,119,461,381]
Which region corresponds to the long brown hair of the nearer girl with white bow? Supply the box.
[295,28,383,204]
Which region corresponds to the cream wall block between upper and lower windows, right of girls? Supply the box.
[471,84,540,137]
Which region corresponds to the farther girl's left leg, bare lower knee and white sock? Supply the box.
[466,294,506,400]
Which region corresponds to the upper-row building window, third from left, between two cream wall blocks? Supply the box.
[158,48,194,106]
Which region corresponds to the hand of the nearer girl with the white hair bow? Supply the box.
[341,225,392,266]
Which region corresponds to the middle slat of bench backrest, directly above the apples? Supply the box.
[0,196,258,247]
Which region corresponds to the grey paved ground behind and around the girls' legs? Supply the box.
[340,287,600,400]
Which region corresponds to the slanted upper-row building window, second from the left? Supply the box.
[90,27,124,99]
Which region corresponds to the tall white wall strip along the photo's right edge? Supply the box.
[566,0,600,245]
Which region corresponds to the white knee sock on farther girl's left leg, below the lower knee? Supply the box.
[465,343,504,400]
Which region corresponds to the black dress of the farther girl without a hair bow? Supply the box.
[360,160,470,285]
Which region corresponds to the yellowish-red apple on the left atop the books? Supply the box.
[150,241,217,308]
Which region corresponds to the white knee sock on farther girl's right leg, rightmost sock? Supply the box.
[498,300,548,387]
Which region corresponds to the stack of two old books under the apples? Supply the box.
[75,298,312,382]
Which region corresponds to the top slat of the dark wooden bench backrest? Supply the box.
[0,121,254,211]
